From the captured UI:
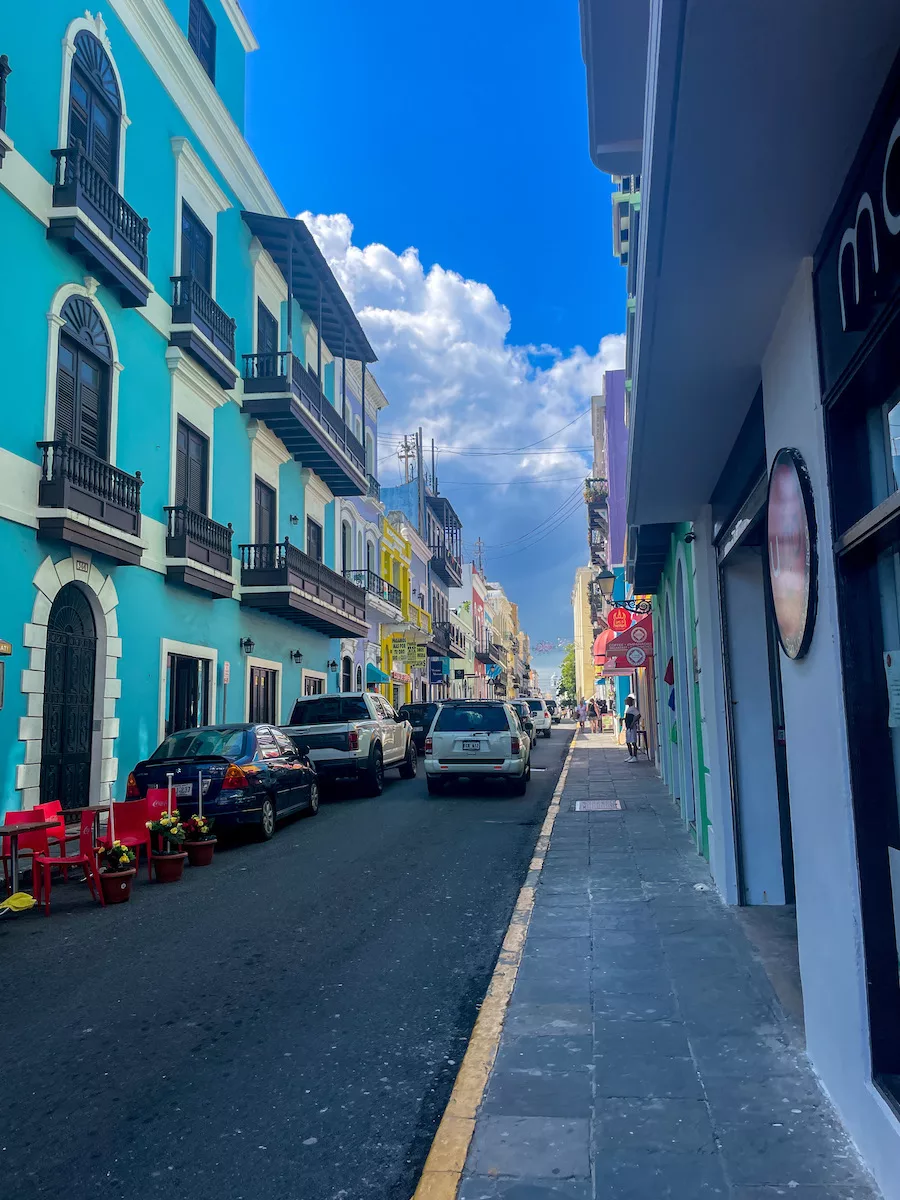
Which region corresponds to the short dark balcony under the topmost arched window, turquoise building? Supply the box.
[47,145,150,308]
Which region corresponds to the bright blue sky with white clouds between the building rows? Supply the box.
[244,0,624,676]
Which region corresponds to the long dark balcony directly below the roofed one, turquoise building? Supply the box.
[240,538,368,637]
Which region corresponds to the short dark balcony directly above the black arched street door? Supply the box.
[37,437,143,566]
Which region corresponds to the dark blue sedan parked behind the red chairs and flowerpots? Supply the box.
[126,725,319,839]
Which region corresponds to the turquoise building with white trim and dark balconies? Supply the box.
[0,0,383,808]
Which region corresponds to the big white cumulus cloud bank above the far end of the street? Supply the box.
[300,212,625,641]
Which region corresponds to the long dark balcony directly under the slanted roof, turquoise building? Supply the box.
[244,350,368,496]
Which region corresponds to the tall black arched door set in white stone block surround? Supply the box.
[41,583,97,809]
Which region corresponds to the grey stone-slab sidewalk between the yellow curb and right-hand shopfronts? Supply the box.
[460,733,877,1200]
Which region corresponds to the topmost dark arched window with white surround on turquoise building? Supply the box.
[68,30,122,187]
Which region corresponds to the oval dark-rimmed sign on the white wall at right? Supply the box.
[766,449,817,659]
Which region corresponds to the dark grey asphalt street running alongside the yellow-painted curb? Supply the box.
[0,726,570,1200]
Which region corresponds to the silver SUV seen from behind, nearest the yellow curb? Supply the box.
[425,700,532,796]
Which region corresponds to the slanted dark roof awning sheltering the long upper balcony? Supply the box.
[241,212,376,362]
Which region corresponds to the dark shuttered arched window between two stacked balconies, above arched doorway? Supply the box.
[54,296,113,458]
